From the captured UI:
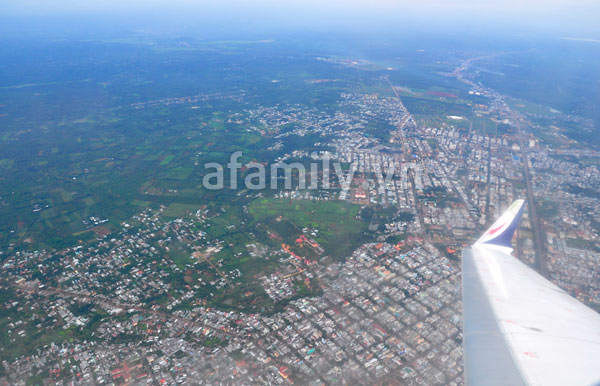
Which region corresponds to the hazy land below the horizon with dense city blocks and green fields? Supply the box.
[0,0,600,385]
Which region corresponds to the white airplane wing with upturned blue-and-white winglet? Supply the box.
[462,200,600,386]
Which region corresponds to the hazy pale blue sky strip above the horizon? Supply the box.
[0,0,600,39]
